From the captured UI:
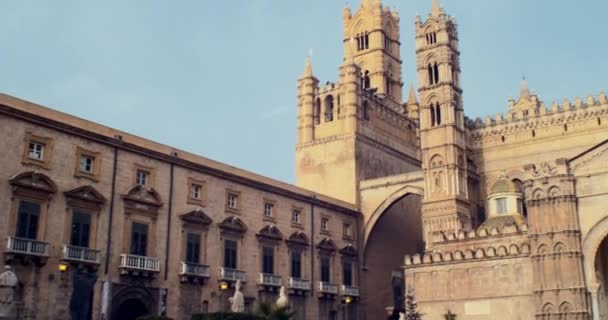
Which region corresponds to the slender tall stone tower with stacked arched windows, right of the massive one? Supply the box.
[416,0,471,243]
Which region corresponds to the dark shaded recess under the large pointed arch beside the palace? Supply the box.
[363,194,424,319]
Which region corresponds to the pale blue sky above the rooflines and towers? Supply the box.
[0,0,608,182]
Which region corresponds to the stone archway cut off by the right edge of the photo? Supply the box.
[583,217,608,320]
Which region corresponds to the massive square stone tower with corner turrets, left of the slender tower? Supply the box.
[296,0,420,204]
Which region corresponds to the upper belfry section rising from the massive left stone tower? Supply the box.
[343,0,403,106]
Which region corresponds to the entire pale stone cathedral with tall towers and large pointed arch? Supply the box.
[296,0,608,320]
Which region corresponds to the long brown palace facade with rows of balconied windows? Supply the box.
[0,91,361,320]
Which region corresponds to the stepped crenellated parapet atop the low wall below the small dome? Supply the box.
[404,225,530,267]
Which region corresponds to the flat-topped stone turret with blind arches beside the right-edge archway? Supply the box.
[525,159,589,319]
